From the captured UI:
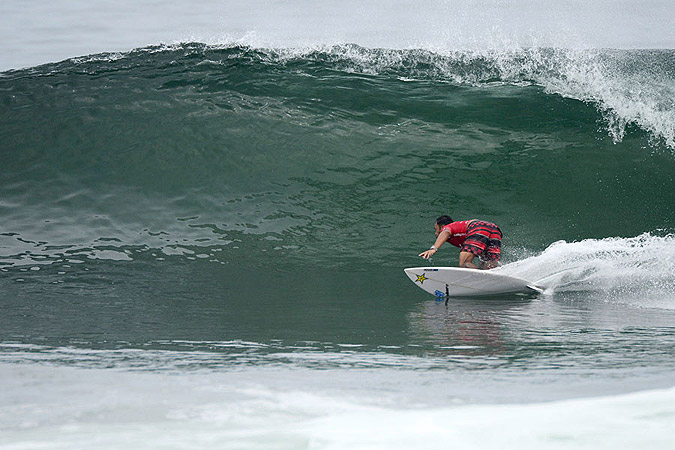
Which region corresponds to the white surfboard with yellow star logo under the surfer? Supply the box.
[404,267,543,298]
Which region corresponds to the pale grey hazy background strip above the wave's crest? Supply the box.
[0,0,675,70]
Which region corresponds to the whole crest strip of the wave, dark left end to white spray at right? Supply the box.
[13,42,675,149]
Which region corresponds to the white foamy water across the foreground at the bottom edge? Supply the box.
[0,364,675,450]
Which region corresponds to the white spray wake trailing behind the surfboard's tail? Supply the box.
[500,233,675,309]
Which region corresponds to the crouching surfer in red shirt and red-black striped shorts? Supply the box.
[419,215,502,269]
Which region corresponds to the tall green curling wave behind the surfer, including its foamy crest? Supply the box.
[0,44,675,267]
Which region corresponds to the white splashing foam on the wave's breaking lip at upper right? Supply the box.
[312,42,675,149]
